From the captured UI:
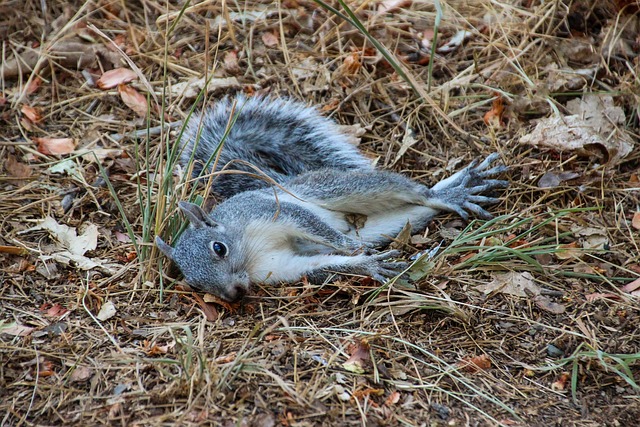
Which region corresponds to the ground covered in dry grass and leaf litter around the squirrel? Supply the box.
[0,0,640,426]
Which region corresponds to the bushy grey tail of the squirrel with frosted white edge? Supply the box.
[180,95,371,198]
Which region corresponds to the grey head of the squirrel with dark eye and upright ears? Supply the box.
[156,202,250,302]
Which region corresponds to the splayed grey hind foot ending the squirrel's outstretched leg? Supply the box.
[427,153,509,220]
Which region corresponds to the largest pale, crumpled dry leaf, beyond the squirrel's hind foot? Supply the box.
[520,94,633,164]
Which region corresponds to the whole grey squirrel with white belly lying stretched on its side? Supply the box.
[156,95,508,301]
